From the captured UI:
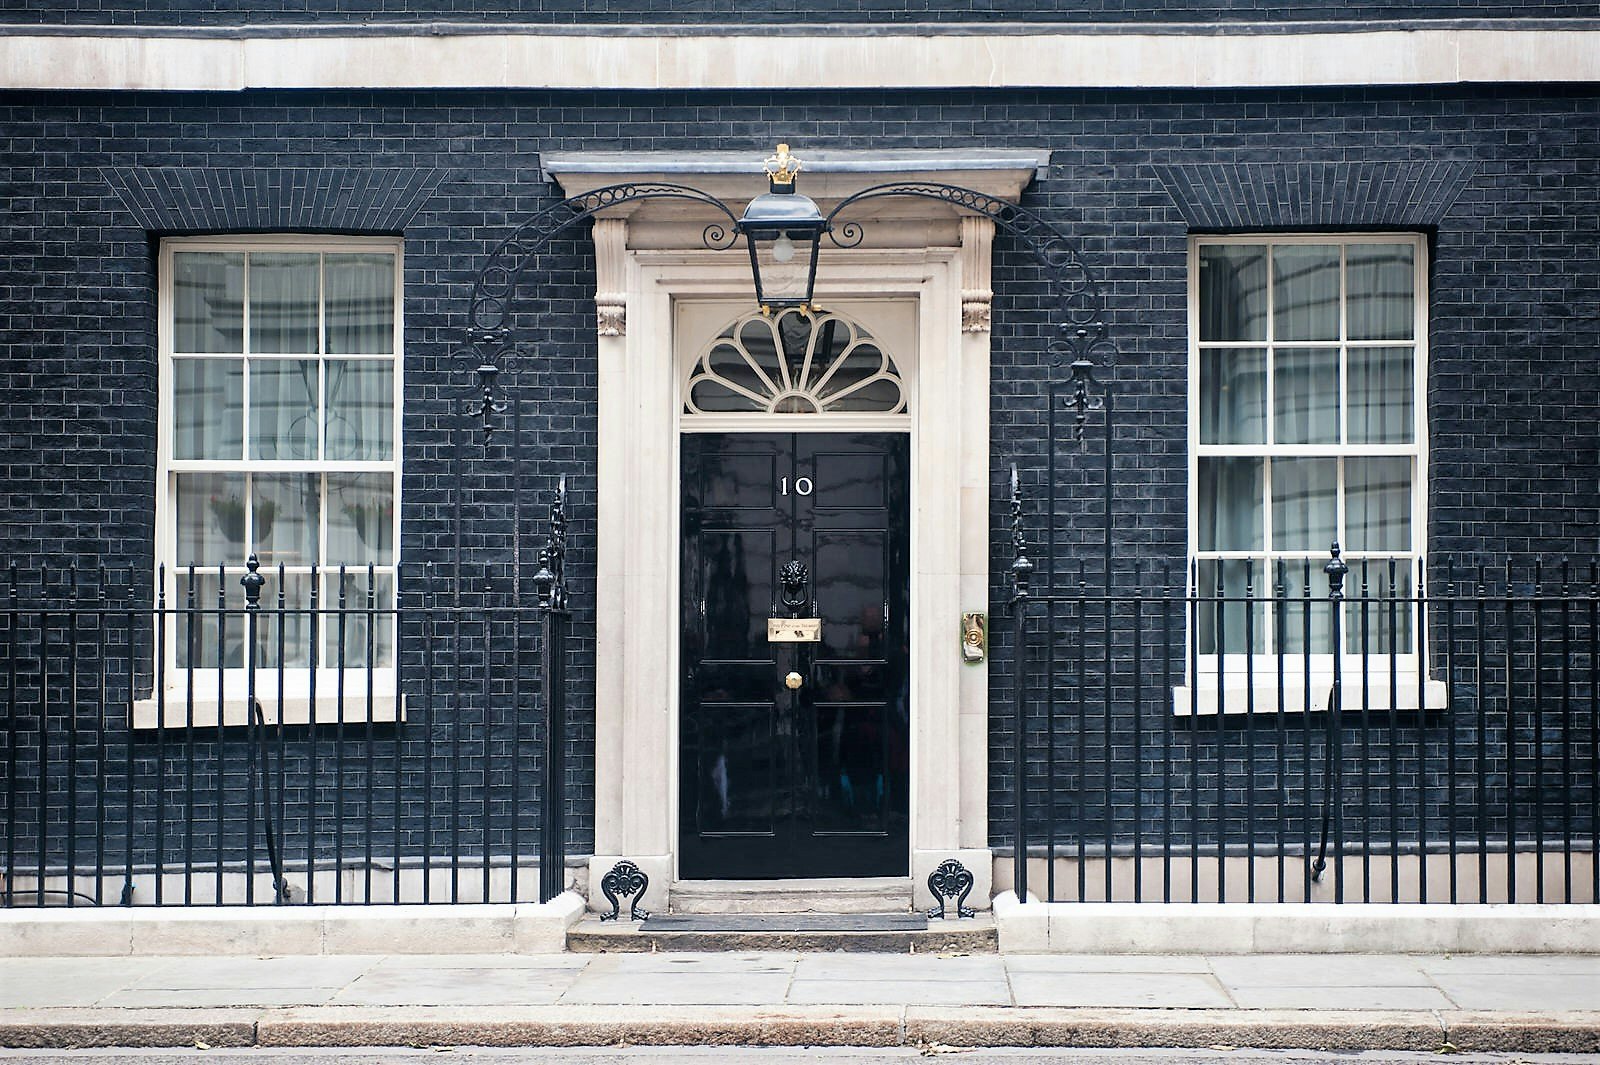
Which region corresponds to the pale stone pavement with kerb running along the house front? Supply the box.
[0,951,1600,1052]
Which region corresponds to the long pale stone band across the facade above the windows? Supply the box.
[0,19,1600,91]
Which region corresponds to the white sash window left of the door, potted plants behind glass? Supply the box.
[148,237,402,725]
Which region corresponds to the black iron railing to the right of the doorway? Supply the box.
[997,486,1600,902]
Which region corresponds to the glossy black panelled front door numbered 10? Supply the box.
[678,433,910,880]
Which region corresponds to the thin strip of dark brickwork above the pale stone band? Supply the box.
[6,0,1595,26]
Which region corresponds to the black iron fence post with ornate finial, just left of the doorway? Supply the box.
[533,477,568,902]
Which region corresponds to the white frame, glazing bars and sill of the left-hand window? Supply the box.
[133,233,405,729]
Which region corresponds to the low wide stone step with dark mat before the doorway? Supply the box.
[566,911,1000,955]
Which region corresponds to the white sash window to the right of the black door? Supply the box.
[1189,233,1427,710]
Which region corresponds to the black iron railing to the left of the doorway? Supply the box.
[0,501,570,905]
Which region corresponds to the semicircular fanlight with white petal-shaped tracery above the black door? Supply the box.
[683,309,906,414]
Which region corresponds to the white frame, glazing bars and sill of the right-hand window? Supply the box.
[1173,230,1445,715]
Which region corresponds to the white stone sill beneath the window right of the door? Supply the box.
[1173,667,1446,718]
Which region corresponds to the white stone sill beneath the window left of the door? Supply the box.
[131,668,405,731]
